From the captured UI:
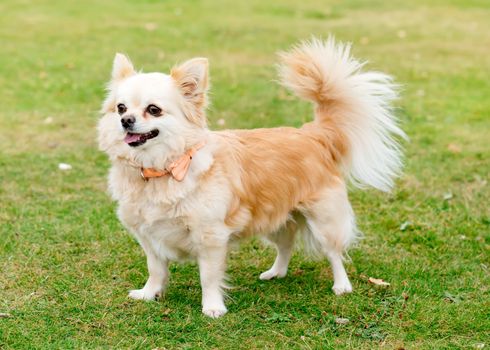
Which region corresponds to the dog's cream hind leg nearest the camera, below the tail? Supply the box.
[303,185,357,295]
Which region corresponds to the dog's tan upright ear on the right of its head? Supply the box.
[170,57,209,127]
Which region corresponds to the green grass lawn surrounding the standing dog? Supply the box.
[0,0,490,349]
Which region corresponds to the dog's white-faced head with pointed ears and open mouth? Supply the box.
[98,54,208,167]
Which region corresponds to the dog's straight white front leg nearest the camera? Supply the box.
[198,242,228,318]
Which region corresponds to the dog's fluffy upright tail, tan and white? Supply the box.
[279,37,406,191]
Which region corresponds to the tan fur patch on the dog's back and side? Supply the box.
[207,122,346,235]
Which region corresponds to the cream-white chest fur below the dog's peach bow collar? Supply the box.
[109,146,234,261]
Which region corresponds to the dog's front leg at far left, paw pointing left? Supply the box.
[129,246,168,300]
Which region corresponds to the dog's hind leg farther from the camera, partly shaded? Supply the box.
[259,220,298,280]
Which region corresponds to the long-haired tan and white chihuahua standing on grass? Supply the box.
[98,38,405,317]
